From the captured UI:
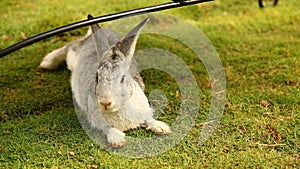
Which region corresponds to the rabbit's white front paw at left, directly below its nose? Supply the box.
[107,128,126,147]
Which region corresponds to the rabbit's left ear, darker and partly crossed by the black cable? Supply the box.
[88,14,109,59]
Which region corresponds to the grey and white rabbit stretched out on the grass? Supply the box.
[40,15,171,147]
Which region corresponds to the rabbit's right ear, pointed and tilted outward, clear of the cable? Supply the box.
[120,18,149,68]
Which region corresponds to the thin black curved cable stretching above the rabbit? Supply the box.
[0,0,214,58]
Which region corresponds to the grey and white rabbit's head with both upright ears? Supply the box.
[92,16,148,112]
